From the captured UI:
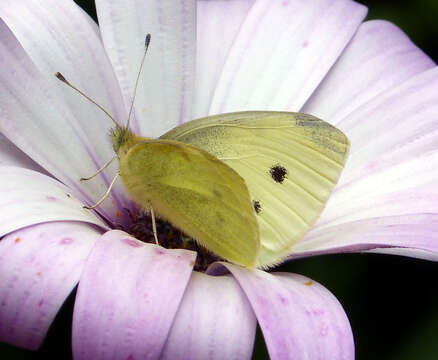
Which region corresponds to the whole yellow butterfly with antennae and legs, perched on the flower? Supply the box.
[55,34,350,268]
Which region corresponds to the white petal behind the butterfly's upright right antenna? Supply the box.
[96,0,196,137]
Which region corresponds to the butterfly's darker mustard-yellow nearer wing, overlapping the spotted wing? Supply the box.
[119,140,260,267]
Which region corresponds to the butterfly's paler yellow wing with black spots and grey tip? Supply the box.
[161,112,349,267]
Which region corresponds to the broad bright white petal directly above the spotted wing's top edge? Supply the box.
[210,0,366,113]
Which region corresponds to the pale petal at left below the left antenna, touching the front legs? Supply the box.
[0,19,127,219]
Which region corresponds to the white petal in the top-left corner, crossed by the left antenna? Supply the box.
[0,0,126,122]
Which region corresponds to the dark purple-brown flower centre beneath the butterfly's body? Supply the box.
[123,210,223,272]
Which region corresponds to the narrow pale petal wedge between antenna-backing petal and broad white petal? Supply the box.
[193,0,255,118]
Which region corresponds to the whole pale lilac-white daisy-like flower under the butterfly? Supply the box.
[0,0,438,359]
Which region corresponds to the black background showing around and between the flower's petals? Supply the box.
[0,0,438,360]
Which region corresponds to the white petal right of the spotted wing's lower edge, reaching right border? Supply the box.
[315,150,438,228]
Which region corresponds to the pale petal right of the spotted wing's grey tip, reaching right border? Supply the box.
[338,67,438,180]
